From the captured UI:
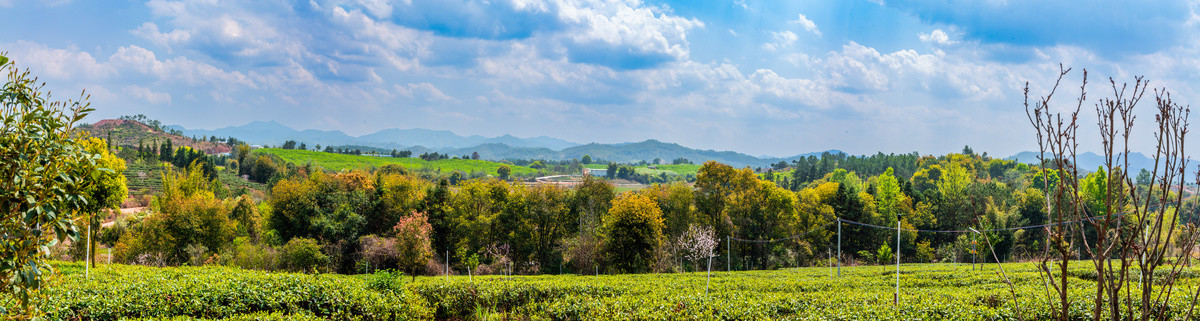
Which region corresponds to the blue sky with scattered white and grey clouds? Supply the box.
[0,0,1200,157]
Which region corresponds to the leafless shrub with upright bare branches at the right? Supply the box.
[1025,66,1200,320]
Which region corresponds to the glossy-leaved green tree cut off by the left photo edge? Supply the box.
[0,53,100,317]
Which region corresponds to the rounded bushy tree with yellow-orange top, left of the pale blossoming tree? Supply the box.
[604,193,662,272]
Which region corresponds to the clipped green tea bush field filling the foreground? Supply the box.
[14,261,1200,320]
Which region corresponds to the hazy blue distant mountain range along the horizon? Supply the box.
[168,121,841,166]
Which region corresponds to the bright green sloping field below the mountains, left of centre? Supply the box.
[268,149,538,176]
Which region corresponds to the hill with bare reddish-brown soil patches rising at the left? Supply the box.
[78,120,232,155]
